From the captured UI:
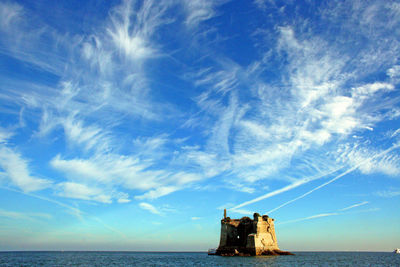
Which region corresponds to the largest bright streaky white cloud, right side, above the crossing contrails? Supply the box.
[206,19,398,197]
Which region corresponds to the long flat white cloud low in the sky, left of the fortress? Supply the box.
[50,146,207,202]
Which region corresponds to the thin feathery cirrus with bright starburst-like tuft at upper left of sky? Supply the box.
[5,1,175,136]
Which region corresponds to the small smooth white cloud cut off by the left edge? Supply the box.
[0,147,51,192]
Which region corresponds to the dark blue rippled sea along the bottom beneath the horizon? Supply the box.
[0,252,400,267]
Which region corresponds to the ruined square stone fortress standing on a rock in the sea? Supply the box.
[215,209,293,256]
